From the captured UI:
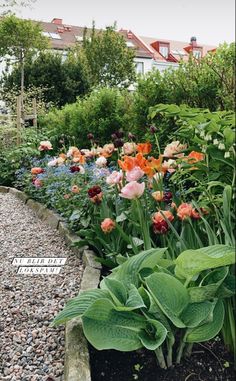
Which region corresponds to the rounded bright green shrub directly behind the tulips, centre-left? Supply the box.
[40,88,135,147]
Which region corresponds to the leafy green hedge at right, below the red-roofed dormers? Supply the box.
[134,43,235,137]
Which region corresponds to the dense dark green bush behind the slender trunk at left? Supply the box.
[1,51,90,107]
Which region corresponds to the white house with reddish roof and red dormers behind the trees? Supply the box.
[36,18,216,74]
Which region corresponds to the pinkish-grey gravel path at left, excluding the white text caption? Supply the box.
[0,193,83,381]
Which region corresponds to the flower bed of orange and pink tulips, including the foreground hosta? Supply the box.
[6,105,235,378]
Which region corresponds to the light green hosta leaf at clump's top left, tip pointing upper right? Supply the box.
[108,248,166,287]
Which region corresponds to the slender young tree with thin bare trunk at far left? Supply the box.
[0,15,48,117]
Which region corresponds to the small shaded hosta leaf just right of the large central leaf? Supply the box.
[181,300,217,328]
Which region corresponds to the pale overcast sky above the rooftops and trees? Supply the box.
[15,0,235,45]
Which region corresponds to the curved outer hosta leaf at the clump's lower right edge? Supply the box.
[185,300,224,343]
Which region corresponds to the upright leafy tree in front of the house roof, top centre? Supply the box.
[73,25,136,88]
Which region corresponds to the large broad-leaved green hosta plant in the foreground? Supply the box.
[52,245,235,368]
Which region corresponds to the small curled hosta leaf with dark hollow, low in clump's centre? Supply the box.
[139,319,167,351]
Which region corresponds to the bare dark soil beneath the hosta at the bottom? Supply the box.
[89,340,235,381]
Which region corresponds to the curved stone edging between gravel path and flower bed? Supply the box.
[0,186,101,381]
